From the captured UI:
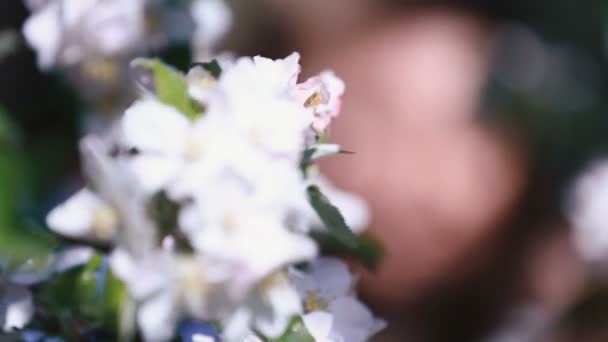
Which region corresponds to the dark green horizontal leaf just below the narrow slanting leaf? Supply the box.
[311,231,384,270]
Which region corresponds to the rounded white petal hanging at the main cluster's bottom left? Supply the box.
[137,291,180,342]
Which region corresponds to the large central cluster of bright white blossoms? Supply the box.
[47,53,383,342]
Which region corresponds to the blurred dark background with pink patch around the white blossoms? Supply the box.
[0,0,608,342]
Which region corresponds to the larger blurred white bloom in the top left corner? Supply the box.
[23,0,145,69]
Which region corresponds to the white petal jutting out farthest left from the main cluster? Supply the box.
[46,189,111,238]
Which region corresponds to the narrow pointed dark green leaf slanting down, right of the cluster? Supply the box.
[307,185,358,248]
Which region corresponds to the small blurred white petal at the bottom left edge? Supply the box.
[0,285,34,332]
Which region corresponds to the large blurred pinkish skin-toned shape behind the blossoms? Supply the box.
[266,0,524,305]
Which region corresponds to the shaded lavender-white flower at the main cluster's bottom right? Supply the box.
[290,258,386,342]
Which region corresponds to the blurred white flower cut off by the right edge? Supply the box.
[566,160,608,262]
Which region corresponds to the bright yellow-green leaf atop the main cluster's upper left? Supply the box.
[132,58,200,120]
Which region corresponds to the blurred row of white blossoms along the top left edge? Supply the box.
[23,0,232,69]
